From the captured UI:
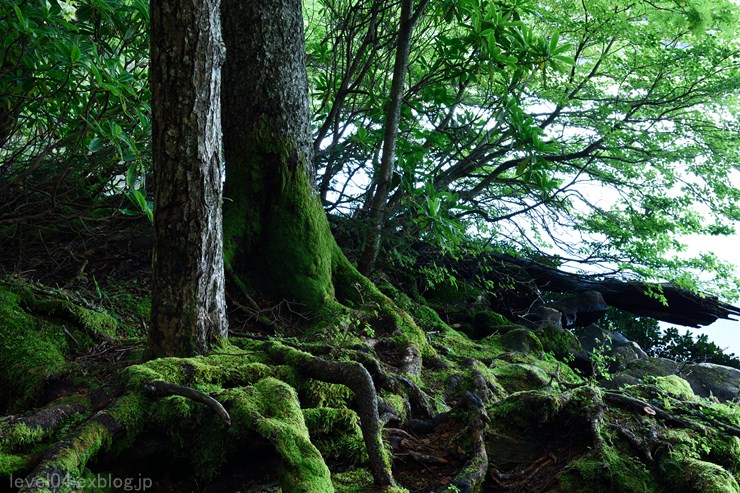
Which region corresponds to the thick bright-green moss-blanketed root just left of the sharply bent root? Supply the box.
[222,377,334,493]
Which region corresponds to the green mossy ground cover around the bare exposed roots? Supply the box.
[0,274,740,493]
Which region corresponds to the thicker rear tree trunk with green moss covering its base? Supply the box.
[222,0,336,307]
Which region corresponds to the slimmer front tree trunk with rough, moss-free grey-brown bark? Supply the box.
[149,0,228,356]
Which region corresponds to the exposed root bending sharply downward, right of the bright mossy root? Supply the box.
[268,343,394,486]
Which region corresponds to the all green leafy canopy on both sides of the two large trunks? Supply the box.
[0,0,740,298]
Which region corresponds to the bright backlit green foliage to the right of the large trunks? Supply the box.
[307,0,740,298]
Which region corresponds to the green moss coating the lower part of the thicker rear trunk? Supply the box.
[224,127,335,310]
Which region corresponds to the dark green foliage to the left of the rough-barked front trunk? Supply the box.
[0,0,151,229]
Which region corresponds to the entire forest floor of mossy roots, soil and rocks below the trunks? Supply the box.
[0,223,740,493]
